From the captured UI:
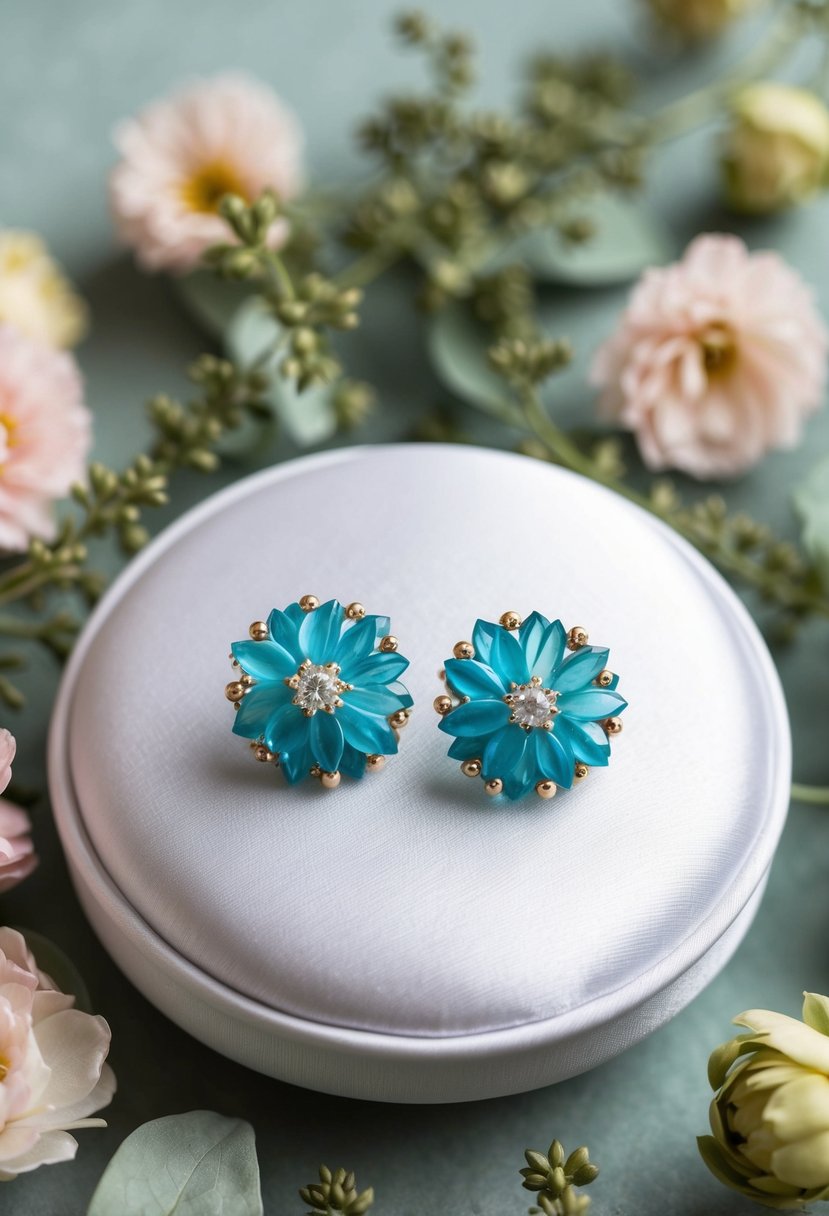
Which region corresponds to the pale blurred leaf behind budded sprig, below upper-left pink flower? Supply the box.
[225,295,337,447]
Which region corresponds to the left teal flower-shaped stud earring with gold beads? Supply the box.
[225,596,412,789]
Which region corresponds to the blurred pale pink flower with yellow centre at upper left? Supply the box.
[109,75,301,271]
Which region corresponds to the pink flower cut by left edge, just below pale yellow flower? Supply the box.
[0,325,91,550]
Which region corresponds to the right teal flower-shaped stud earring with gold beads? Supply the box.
[434,612,627,799]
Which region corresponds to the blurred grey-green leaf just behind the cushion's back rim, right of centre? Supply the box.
[427,303,515,418]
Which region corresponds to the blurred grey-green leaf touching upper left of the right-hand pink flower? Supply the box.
[497,195,672,287]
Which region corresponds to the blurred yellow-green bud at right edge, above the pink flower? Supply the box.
[723,80,829,214]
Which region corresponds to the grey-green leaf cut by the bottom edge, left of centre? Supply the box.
[88,1110,263,1216]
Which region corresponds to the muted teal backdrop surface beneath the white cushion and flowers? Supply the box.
[0,0,829,1216]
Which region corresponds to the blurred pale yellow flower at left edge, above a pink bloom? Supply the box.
[0,229,86,347]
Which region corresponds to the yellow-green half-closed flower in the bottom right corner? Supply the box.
[698,992,829,1209]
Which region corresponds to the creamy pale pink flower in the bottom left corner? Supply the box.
[0,929,115,1181]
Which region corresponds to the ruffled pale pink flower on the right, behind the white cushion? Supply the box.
[591,236,829,478]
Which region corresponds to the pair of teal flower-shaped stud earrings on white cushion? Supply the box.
[225,596,627,799]
